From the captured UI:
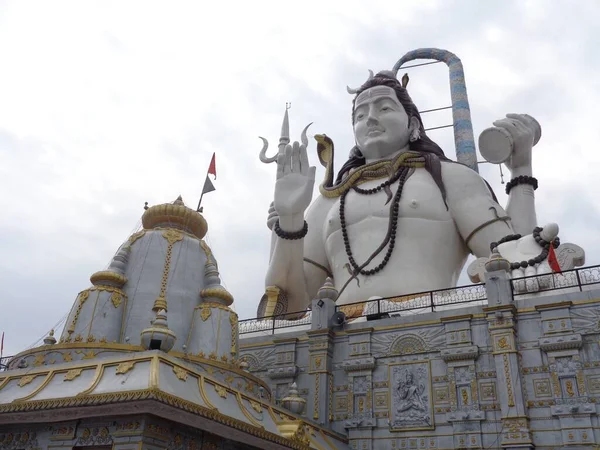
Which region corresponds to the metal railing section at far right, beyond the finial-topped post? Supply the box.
[511,265,600,297]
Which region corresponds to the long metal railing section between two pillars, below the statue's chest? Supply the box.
[336,283,487,319]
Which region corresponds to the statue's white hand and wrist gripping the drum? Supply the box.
[494,114,541,176]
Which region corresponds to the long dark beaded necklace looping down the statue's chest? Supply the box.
[340,167,414,275]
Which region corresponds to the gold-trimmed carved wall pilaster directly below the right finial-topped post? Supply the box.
[483,304,533,449]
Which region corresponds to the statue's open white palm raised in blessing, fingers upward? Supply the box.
[274,142,316,225]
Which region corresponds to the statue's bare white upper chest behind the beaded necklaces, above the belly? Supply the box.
[325,169,452,236]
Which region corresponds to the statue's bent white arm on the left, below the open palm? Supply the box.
[265,196,334,312]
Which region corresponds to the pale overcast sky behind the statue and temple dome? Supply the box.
[0,0,600,355]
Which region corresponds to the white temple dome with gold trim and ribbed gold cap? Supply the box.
[7,196,232,370]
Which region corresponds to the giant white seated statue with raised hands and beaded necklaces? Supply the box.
[259,72,584,315]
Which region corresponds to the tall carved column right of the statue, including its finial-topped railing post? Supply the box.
[483,262,533,450]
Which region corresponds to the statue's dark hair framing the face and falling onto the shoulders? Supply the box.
[335,73,451,203]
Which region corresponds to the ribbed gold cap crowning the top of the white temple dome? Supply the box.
[142,195,208,239]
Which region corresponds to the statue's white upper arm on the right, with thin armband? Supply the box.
[442,163,515,257]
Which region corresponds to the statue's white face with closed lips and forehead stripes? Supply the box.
[354,86,411,161]
